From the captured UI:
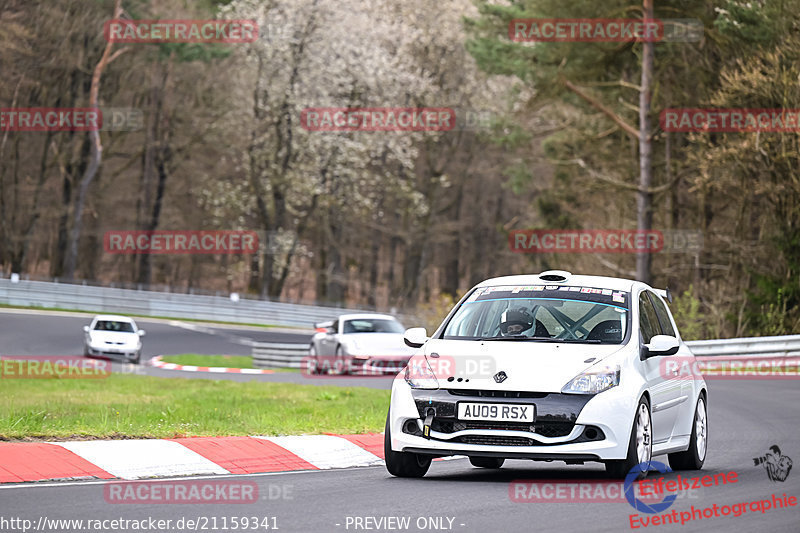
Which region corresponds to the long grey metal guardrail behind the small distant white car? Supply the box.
[0,278,384,327]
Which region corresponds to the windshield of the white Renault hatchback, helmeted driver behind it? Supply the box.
[443,285,630,344]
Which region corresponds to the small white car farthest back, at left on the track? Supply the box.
[83,315,144,363]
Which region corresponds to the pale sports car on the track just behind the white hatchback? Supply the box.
[308,313,416,374]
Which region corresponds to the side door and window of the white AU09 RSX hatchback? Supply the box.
[639,291,681,444]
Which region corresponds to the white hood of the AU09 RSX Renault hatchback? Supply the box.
[425,339,624,392]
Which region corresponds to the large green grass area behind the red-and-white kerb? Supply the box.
[0,374,389,440]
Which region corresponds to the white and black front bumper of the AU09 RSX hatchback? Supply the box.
[390,379,630,462]
